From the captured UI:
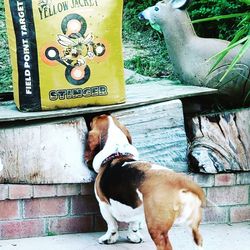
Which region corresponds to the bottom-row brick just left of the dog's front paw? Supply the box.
[48,215,93,234]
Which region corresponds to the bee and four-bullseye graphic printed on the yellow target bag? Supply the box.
[41,14,106,85]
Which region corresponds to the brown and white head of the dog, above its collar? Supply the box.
[84,115,138,172]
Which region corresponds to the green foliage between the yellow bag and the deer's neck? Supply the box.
[123,0,176,79]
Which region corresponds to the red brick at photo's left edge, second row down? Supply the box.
[0,200,20,220]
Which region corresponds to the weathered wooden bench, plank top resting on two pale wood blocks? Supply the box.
[0,80,216,184]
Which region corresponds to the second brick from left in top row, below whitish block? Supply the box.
[9,185,32,200]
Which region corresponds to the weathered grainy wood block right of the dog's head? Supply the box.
[112,100,188,172]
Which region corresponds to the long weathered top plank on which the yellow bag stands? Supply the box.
[0,80,217,122]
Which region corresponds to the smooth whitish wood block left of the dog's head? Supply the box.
[0,118,94,184]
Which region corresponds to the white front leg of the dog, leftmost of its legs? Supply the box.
[98,202,119,244]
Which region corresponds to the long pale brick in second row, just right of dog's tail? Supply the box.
[207,186,248,206]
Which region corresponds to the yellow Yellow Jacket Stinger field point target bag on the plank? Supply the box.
[5,0,125,111]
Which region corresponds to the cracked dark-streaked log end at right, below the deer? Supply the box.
[189,108,250,173]
